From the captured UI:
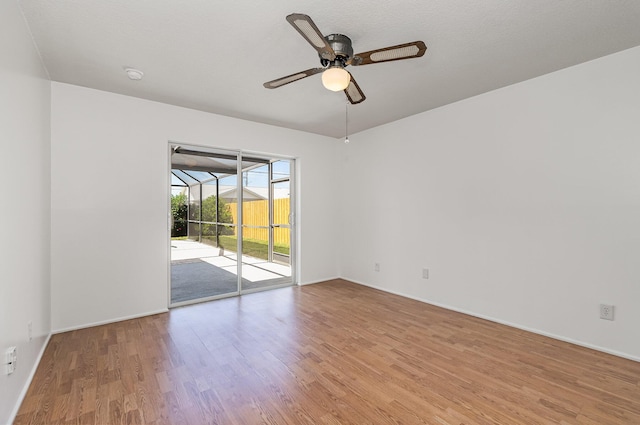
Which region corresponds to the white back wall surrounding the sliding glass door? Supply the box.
[51,82,339,331]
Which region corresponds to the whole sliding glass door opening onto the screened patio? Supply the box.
[170,144,293,306]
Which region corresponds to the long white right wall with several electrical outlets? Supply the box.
[340,48,640,360]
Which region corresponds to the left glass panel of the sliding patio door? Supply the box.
[170,147,239,306]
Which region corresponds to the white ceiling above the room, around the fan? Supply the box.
[18,0,640,138]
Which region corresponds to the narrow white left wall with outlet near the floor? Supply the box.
[0,1,51,424]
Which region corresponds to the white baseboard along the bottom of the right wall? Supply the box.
[341,278,640,362]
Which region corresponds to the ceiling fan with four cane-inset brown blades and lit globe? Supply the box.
[263,13,427,104]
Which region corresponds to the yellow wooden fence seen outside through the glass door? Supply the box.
[227,198,290,246]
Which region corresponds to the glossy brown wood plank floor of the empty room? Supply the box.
[15,280,640,425]
